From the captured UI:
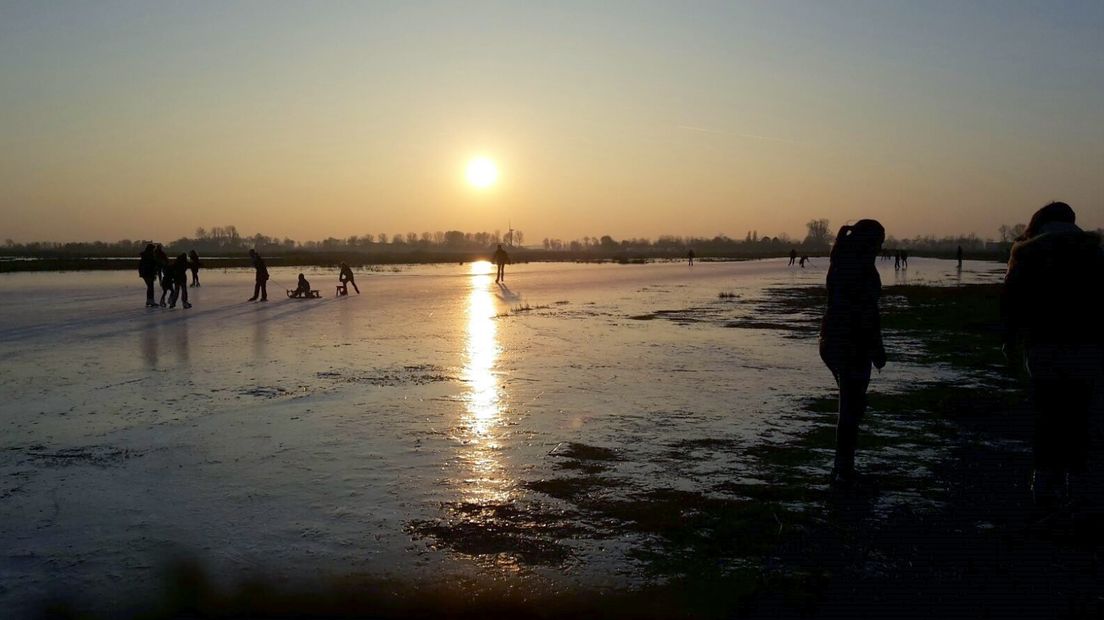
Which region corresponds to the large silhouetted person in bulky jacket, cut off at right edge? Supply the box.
[1001,202,1104,506]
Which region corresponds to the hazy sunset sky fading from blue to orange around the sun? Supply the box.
[0,0,1104,243]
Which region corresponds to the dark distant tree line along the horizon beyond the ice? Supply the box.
[0,218,1090,257]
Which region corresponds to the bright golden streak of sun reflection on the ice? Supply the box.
[460,260,510,502]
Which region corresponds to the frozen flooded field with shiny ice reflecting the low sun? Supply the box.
[0,258,1001,610]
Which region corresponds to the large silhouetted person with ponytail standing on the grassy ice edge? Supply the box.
[819,220,885,488]
